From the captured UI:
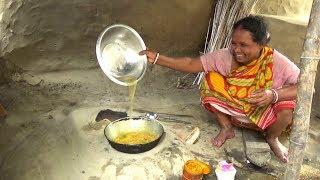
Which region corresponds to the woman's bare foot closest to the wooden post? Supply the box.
[266,138,288,163]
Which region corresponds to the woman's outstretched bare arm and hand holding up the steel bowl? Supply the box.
[139,50,204,73]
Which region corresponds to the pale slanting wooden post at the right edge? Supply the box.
[284,0,320,180]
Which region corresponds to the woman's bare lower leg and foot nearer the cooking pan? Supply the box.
[212,111,234,147]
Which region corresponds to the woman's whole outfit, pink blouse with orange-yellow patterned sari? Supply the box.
[200,47,300,131]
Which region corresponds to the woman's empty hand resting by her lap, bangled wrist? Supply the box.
[248,89,274,106]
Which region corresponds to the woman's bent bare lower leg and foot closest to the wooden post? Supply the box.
[266,109,293,163]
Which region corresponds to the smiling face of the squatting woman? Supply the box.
[231,28,263,64]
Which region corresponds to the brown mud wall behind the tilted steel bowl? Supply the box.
[0,0,214,83]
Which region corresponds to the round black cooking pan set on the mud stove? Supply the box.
[104,118,164,154]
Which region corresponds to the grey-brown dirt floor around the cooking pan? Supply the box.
[0,65,320,180]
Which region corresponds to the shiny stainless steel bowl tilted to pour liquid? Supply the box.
[96,24,147,86]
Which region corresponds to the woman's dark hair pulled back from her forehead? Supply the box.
[233,15,270,45]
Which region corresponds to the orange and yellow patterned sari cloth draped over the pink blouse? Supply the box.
[200,47,275,129]
